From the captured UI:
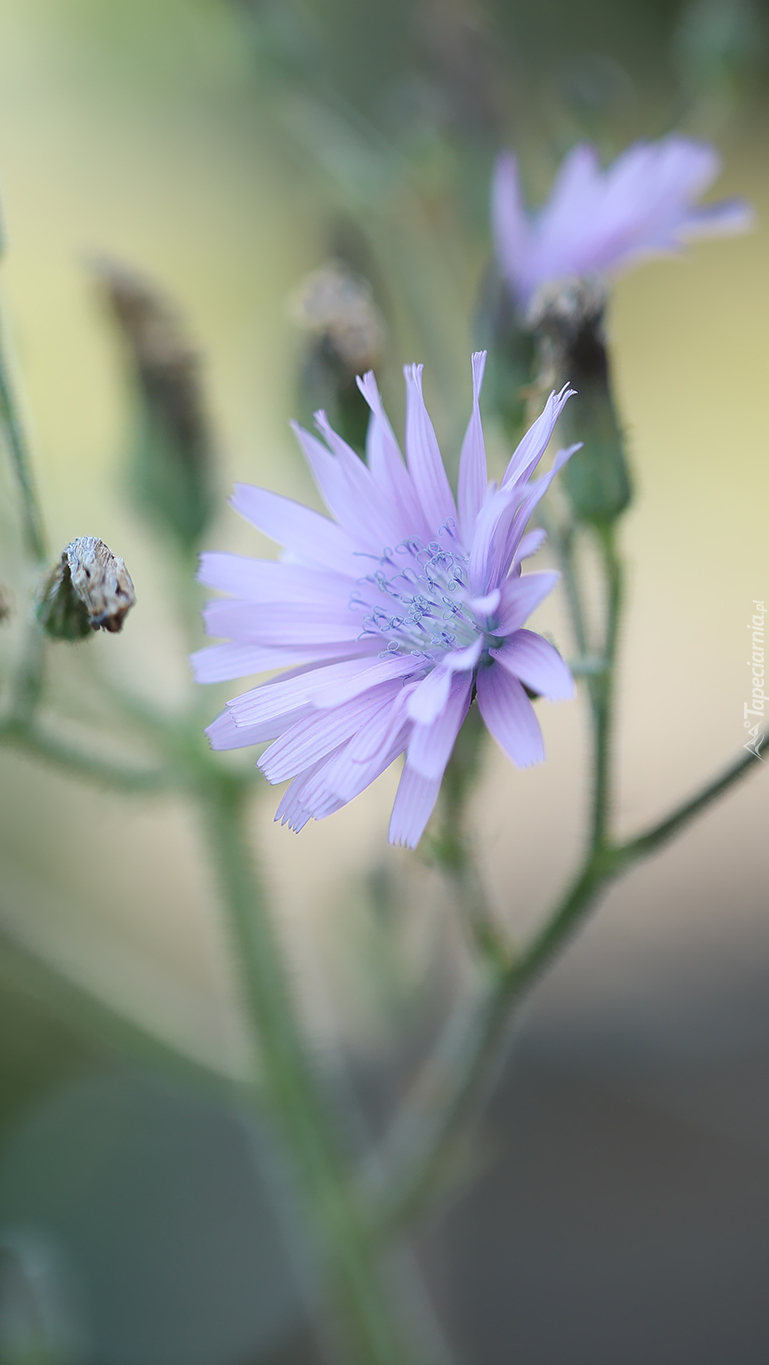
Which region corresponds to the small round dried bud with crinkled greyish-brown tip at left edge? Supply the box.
[37,535,137,640]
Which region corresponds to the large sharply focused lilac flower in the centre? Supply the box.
[193,354,576,848]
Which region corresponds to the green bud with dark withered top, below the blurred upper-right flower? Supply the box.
[529,278,632,523]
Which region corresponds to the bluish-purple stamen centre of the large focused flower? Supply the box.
[350,517,486,662]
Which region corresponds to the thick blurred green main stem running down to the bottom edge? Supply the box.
[204,774,413,1365]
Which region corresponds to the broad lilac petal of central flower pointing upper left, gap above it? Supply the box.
[231,483,366,576]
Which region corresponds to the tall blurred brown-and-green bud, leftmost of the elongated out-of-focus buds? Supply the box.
[90,259,214,549]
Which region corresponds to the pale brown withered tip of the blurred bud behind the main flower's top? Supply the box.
[288,259,385,375]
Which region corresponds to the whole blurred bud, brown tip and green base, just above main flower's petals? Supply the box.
[288,259,385,450]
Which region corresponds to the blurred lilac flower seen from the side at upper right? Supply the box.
[492,134,753,308]
